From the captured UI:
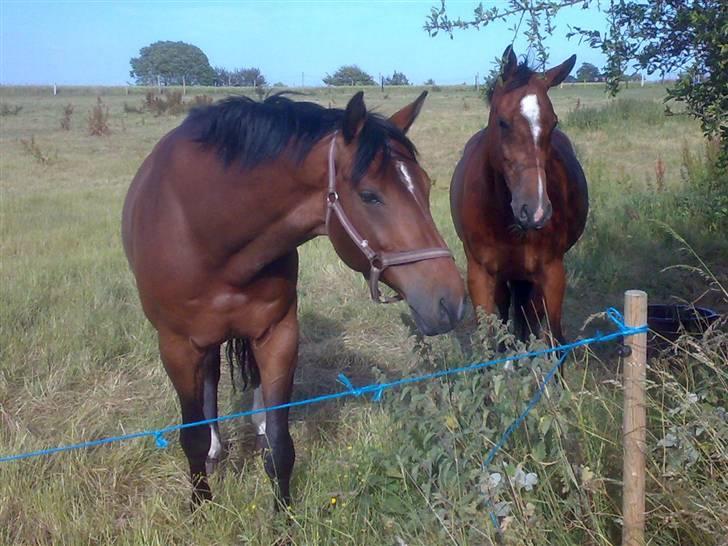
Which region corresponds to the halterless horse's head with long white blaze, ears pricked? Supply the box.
[488,46,576,229]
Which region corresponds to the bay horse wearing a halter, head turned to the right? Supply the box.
[122,92,464,506]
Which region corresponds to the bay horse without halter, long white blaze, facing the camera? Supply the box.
[450,46,589,343]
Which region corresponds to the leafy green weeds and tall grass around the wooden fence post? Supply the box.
[348,300,728,545]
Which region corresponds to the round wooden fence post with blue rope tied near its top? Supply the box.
[622,290,647,546]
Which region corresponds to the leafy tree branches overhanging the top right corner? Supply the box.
[425,0,728,162]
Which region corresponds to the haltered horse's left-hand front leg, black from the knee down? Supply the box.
[159,333,213,507]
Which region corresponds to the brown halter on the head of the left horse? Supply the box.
[326,131,452,303]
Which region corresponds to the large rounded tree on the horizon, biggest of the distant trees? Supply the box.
[130,41,215,85]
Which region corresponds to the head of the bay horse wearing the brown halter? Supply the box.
[328,92,464,335]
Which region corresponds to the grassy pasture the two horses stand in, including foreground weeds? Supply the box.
[0,85,728,546]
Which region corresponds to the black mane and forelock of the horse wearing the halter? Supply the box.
[184,94,417,181]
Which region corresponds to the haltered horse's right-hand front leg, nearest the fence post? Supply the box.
[252,300,298,507]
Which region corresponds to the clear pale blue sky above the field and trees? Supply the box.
[0,0,604,85]
